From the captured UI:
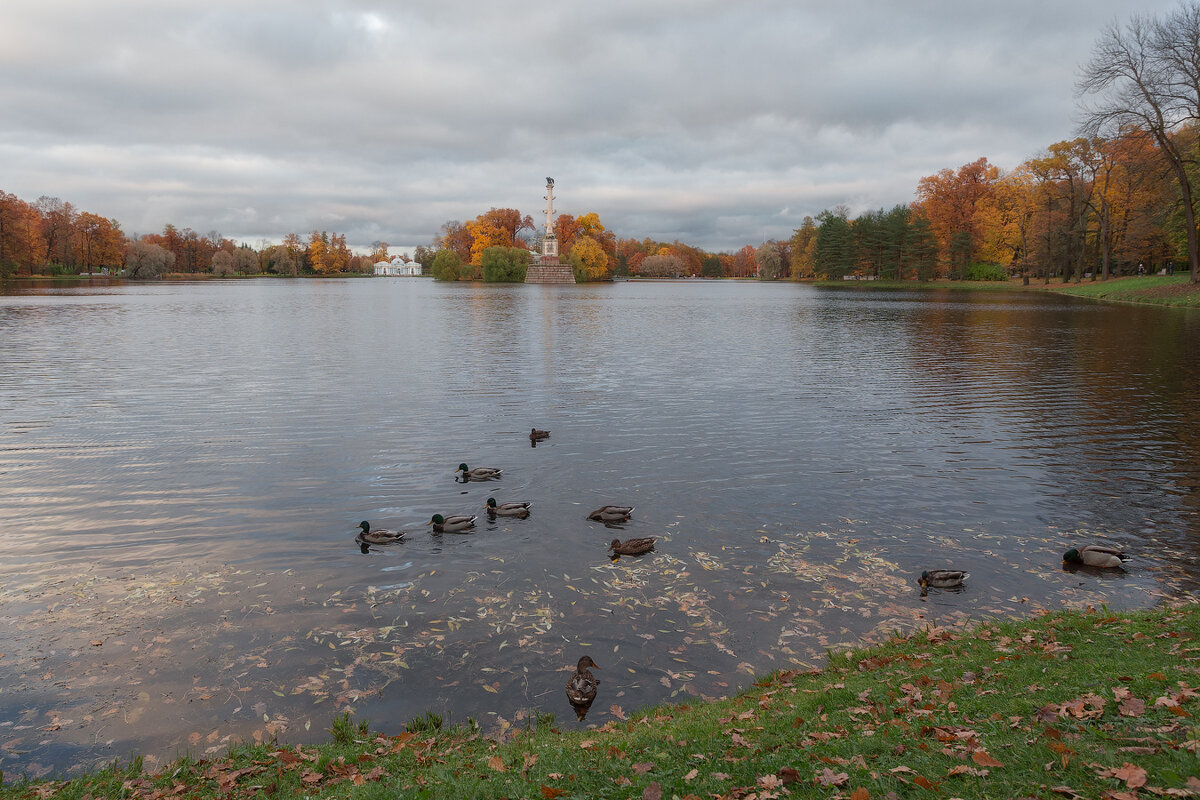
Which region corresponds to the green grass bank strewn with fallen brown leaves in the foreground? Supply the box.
[0,604,1200,800]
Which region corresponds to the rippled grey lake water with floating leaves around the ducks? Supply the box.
[0,279,1200,777]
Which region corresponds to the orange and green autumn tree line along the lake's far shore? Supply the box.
[0,0,1200,282]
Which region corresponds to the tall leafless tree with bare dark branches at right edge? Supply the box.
[1076,0,1200,283]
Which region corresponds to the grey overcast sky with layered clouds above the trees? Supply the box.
[0,0,1177,251]
